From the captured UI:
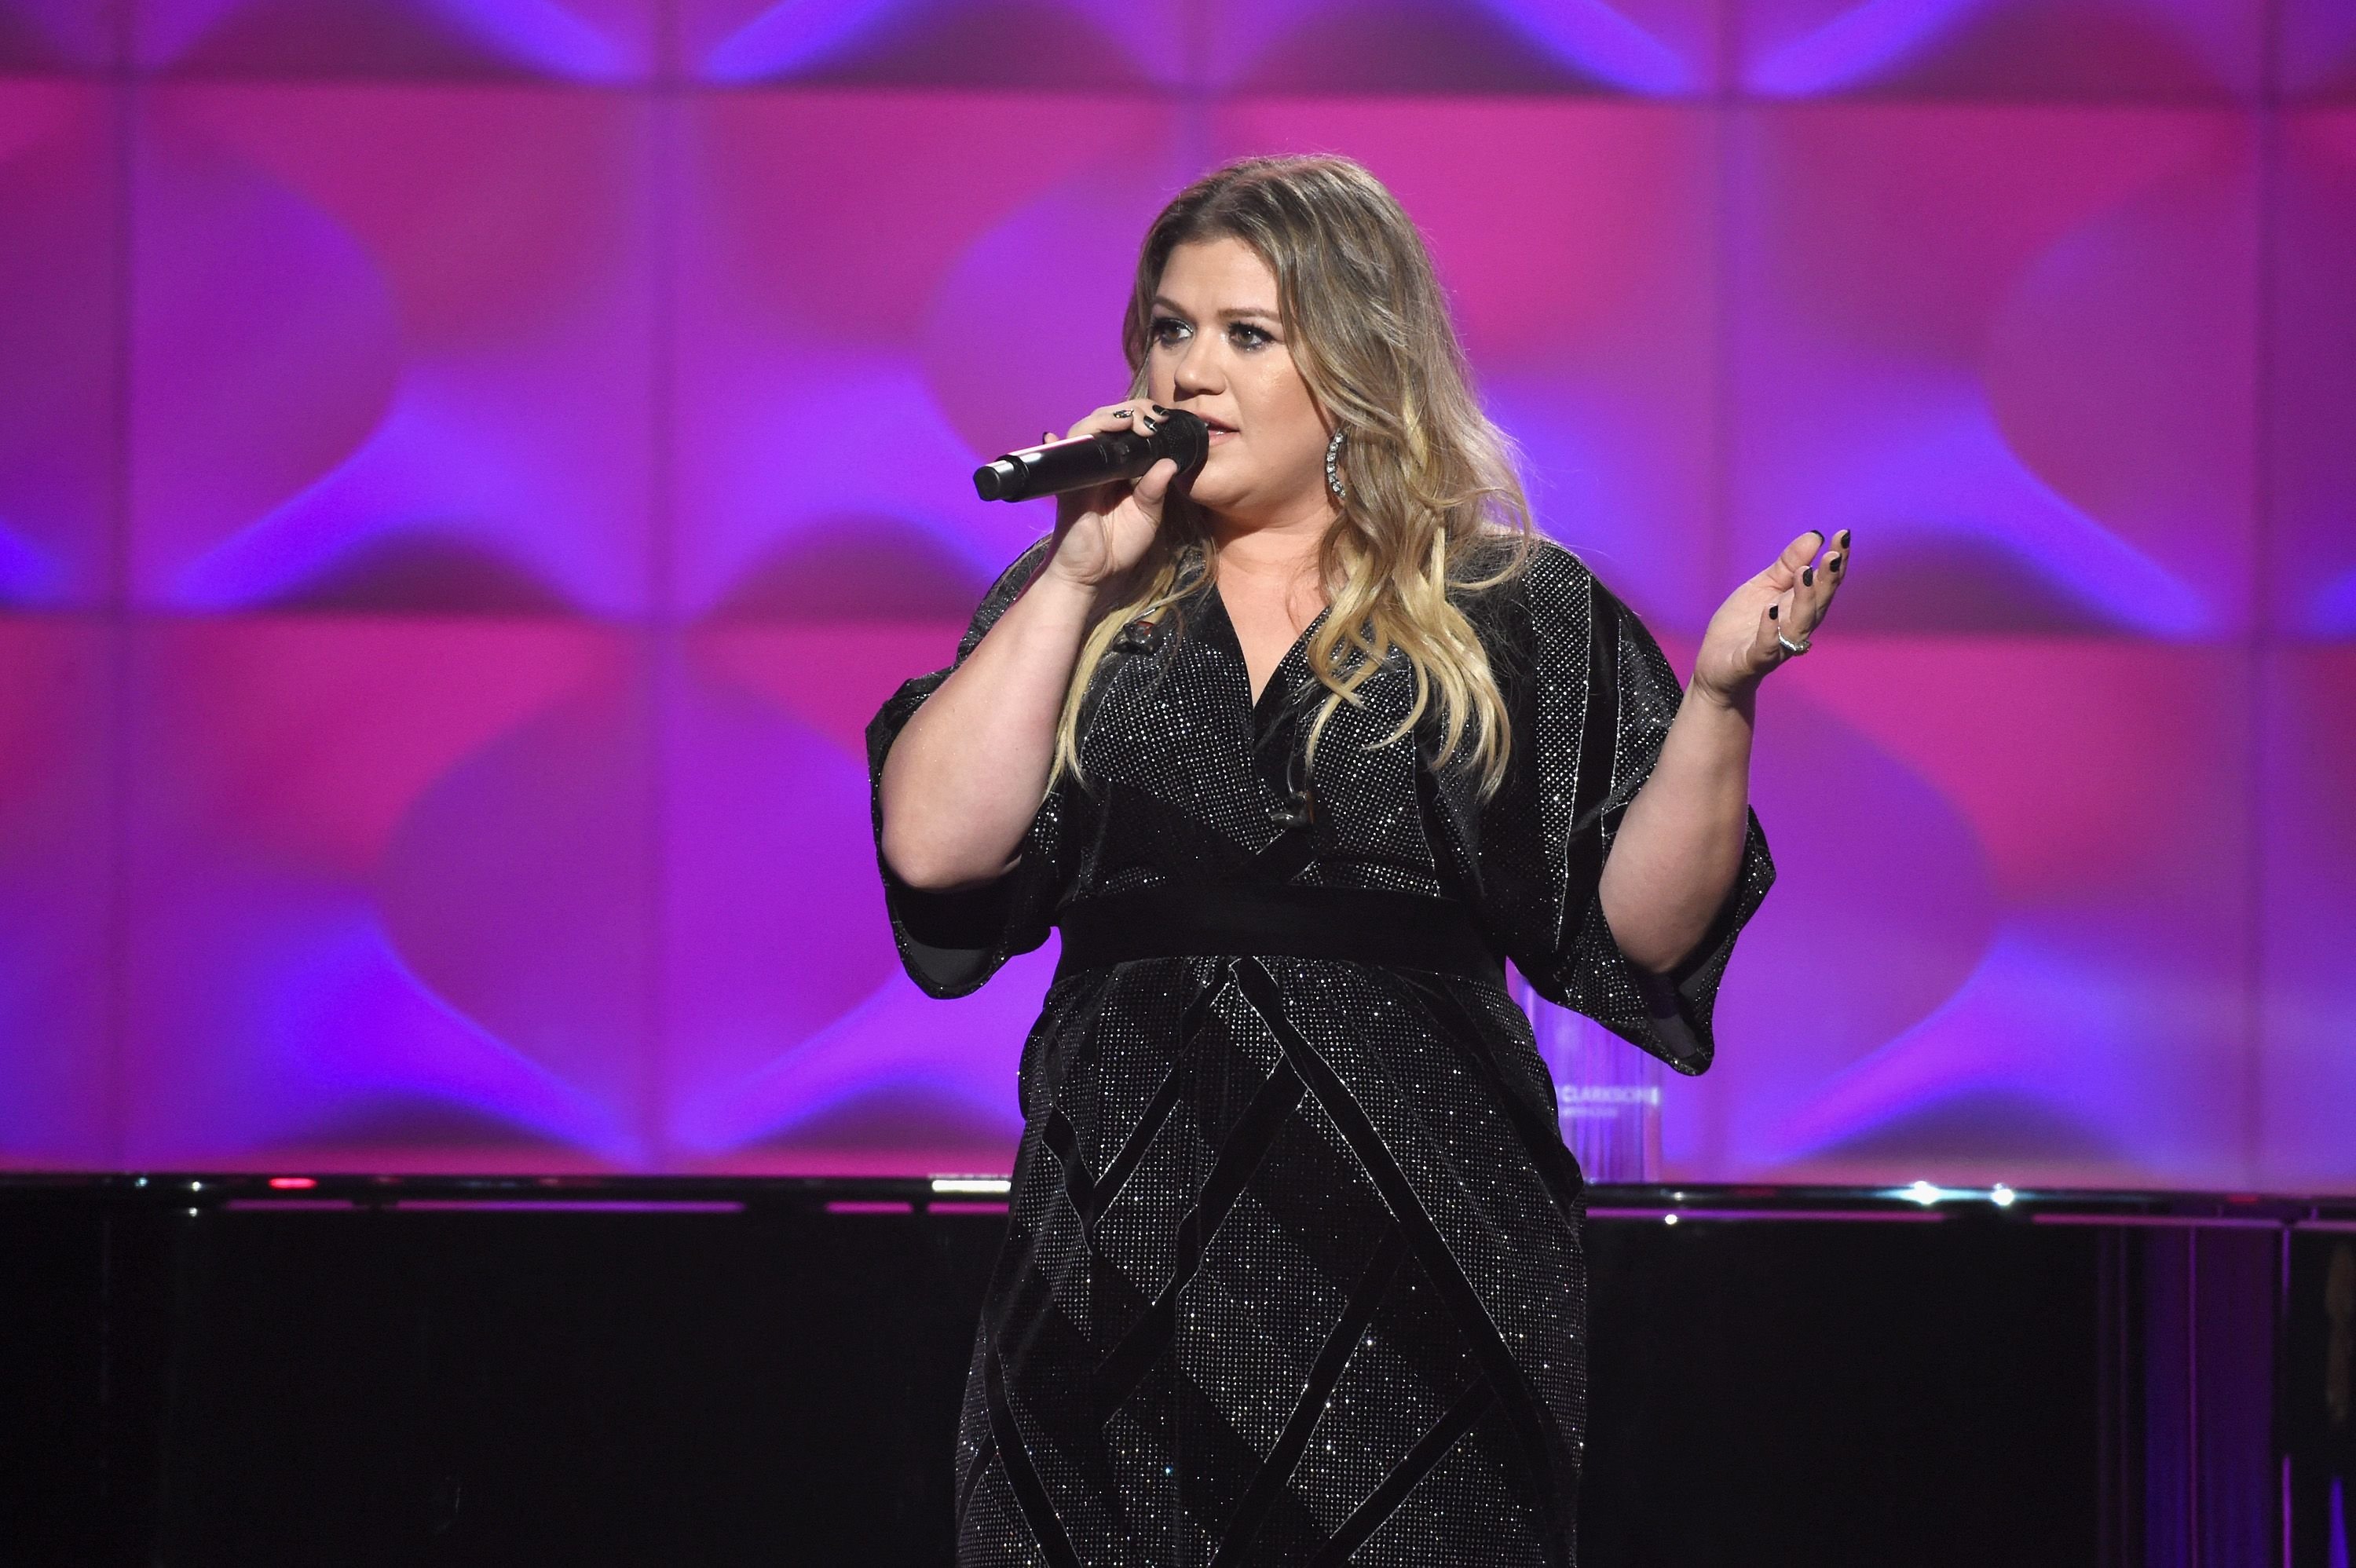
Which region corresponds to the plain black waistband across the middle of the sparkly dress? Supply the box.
[1055,883,1505,984]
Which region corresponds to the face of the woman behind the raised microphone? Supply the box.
[1145,238,1329,528]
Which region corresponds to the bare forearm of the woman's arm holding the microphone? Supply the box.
[881,568,1096,887]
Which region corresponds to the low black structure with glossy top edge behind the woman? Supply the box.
[0,1175,2356,1568]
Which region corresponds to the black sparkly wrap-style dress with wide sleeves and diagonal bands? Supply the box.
[867,542,1774,1568]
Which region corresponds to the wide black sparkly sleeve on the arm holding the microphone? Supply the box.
[867,539,1063,996]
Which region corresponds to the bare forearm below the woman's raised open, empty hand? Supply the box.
[1602,685,1753,972]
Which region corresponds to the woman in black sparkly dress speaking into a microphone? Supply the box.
[867,158,1847,1568]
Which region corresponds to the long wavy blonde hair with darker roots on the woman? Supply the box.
[1053,155,1531,793]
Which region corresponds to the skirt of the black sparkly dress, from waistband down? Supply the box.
[957,890,1586,1568]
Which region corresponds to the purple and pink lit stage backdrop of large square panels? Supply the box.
[0,0,2356,1191]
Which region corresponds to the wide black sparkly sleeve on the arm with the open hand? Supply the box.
[1480,542,1774,1073]
